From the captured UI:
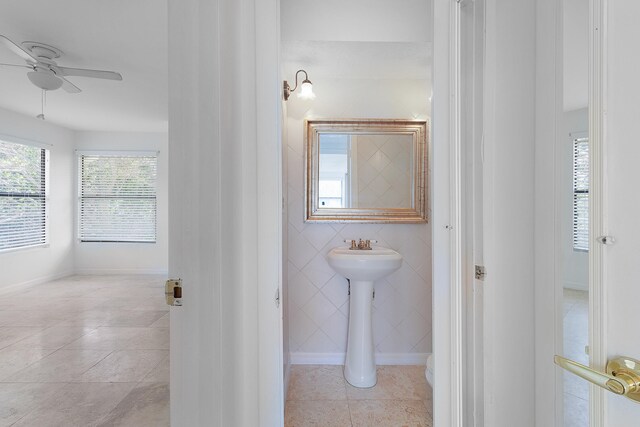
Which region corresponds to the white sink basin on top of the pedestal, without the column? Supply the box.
[327,246,402,281]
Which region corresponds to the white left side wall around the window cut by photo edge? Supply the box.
[0,109,74,288]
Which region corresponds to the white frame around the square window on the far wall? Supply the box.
[76,150,160,245]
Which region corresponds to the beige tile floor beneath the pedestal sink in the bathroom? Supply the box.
[285,365,432,427]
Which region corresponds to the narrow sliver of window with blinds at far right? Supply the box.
[573,138,589,251]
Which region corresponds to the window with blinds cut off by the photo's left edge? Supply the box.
[0,140,49,250]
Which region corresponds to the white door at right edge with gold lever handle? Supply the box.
[600,0,640,427]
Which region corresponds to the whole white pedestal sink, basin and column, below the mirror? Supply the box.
[327,247,402,388]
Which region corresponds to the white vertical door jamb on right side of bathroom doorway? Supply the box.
[431,0,466,427]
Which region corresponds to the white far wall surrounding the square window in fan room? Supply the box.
[72,131,169,274]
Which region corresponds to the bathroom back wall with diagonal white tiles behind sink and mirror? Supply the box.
[287,78,431,364]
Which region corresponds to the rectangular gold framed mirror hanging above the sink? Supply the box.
[304,119,428,224]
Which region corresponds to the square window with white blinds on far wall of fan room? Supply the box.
[78,153,157,243]
